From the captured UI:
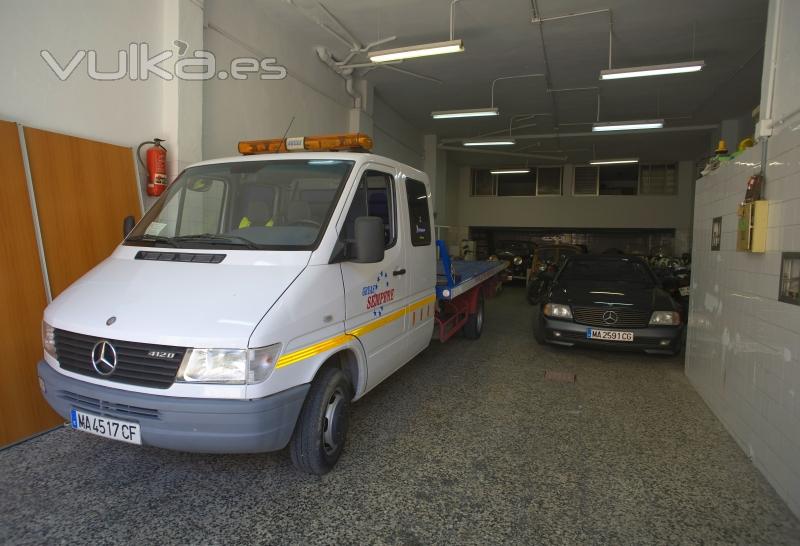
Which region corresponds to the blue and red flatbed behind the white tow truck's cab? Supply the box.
[435,240,508,342]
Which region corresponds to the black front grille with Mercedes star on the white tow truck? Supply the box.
[55,330,186,389]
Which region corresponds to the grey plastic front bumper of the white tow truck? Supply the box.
[38,361,310,453]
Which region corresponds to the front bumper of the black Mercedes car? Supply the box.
[540,316,684,354]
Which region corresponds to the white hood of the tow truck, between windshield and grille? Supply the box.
[45,247,311,348]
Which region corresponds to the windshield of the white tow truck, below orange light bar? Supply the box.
[125,159,353,250]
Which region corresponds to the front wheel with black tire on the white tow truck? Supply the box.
[289,368,352,475]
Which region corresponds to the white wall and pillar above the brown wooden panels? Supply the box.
[0,0,202,206]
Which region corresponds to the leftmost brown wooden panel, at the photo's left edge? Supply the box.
[0,121,61,446]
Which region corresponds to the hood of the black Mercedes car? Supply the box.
[551,281,673,310]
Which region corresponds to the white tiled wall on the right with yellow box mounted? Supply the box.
[686,121,800,515]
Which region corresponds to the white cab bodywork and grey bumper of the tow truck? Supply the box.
[39,152,436,452]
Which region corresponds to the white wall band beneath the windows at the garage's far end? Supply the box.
[457,161,694,253]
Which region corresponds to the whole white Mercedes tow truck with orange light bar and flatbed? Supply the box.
[38,134,506,474]
